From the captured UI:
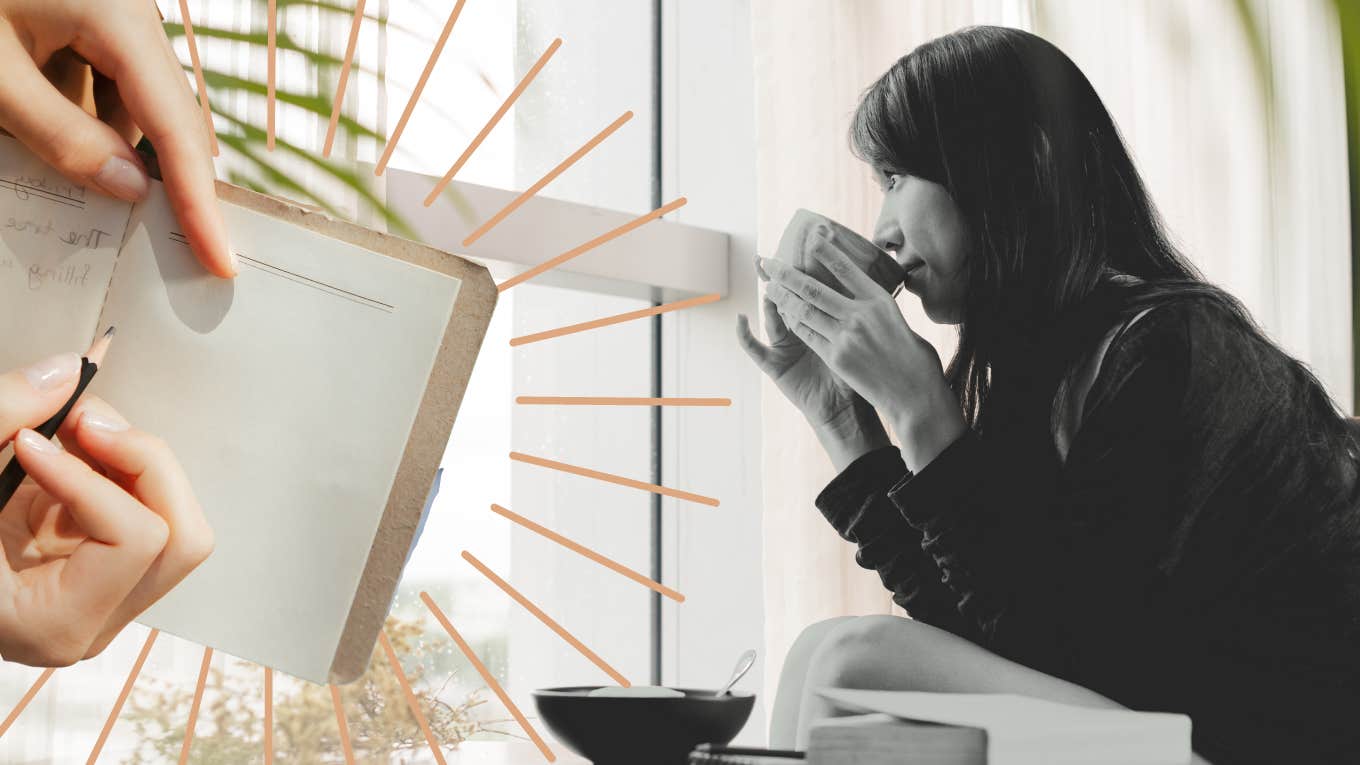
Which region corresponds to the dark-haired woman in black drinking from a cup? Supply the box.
[738,27,1360,765]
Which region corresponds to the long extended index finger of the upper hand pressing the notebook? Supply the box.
[72,3,237,278]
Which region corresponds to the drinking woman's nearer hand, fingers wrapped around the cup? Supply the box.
[760,233,966,471]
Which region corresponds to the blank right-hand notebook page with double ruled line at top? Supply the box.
[94,185,460,682]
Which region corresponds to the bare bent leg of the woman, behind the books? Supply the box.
[794,615,1208,765]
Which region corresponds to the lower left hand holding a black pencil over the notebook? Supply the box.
[0,354,212,667]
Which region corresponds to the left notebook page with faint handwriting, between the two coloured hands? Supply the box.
[0,136,132,372]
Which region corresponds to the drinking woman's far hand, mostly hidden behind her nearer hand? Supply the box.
[737,257,889,471]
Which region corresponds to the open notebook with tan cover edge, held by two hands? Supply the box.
[0,137,496,683]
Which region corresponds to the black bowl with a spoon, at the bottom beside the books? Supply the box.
[533,686,756,765]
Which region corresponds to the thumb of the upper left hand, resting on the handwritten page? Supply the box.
[0,23,150,201]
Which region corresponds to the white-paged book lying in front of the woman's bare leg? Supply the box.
[808,689,1190,765]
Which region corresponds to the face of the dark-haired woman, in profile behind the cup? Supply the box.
[873,174,968,324]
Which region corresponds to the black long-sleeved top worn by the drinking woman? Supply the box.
[817,299,1360,765]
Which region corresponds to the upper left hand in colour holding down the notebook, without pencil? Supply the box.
[0,0,237,276]
